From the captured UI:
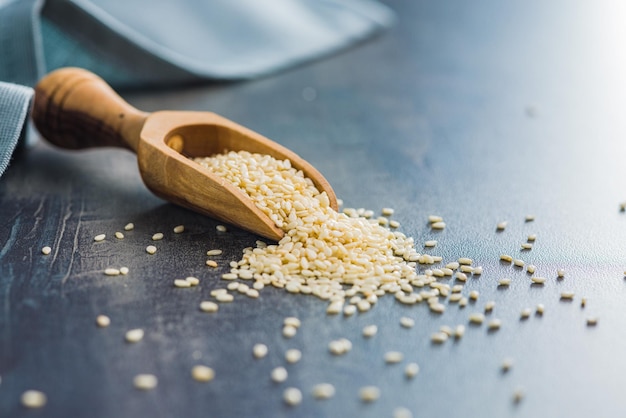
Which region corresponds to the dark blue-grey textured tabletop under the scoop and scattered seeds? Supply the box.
[0,0,626,417]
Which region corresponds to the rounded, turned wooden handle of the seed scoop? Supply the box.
[32,67,148,152]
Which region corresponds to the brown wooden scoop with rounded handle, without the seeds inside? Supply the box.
[32,68,337,241]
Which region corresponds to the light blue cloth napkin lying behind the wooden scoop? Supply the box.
[0,0,394,175]
